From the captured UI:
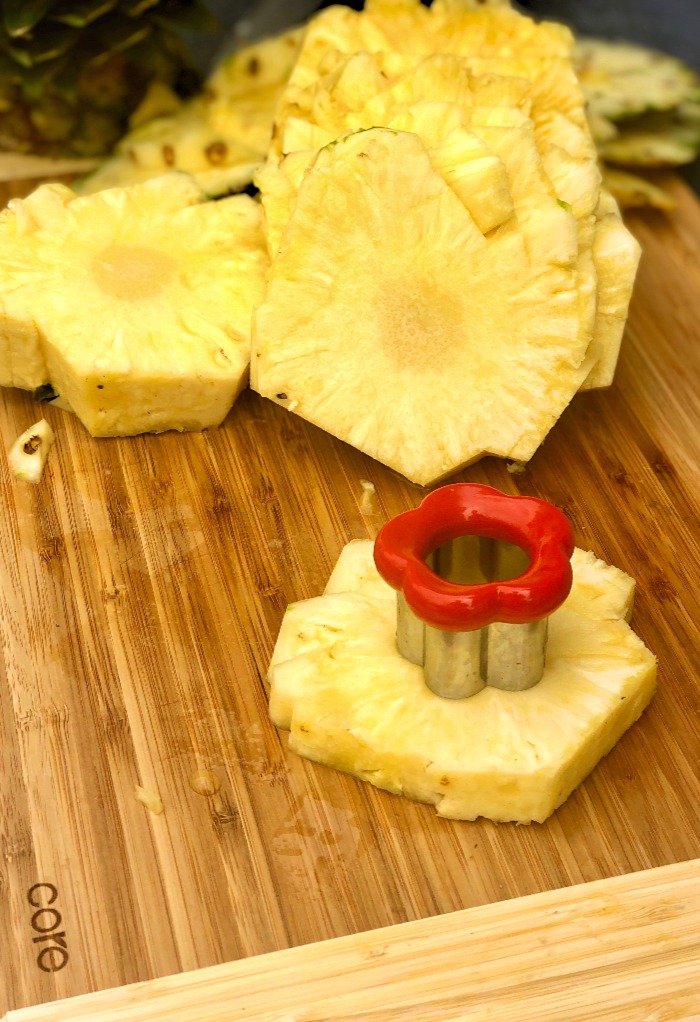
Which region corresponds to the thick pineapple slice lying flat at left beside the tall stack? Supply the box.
[0,174,267,436]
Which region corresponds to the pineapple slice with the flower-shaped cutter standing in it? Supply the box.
[269,541,656,823]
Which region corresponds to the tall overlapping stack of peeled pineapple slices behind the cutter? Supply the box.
[251,0,639,484]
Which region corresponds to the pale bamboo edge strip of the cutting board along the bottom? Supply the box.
[5,860,700,1022]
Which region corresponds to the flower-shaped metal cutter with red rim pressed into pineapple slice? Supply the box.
[374,482,574,699]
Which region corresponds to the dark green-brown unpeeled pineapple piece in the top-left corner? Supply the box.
[0,0,216,156]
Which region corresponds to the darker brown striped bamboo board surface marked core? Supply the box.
[0,171,700,1015]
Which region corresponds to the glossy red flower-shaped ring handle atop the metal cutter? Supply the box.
[374,482,574,632]
